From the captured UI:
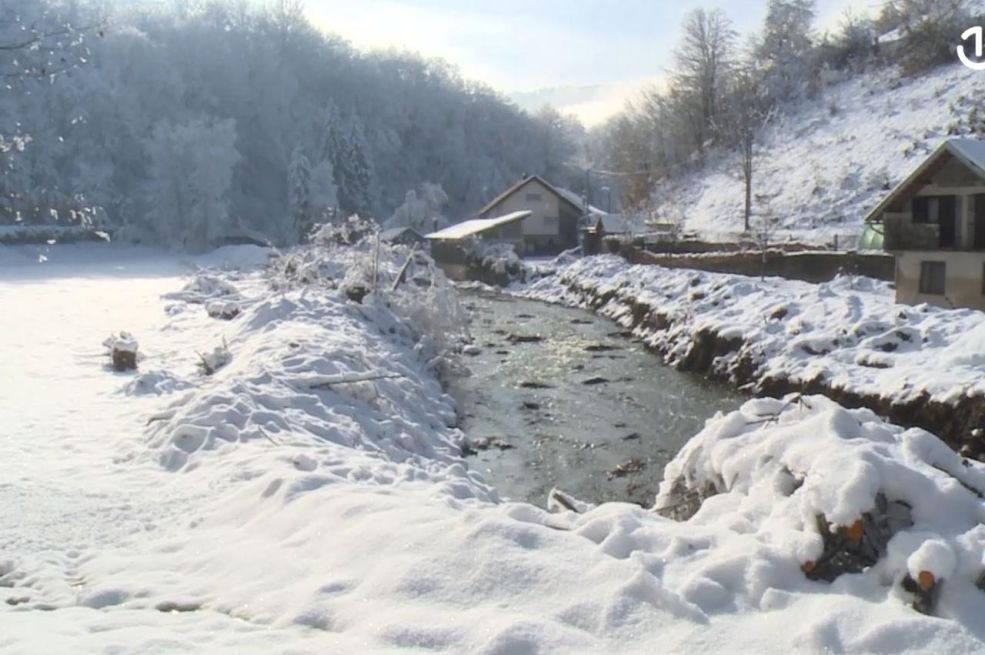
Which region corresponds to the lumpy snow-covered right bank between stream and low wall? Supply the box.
[524,255,985,404]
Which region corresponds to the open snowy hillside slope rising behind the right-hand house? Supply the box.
[655,63,985,243]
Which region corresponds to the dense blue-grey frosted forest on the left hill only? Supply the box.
[0,0,581,251]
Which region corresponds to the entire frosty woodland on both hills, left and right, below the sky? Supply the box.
[0,0,973,251]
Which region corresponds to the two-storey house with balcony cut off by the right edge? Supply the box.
[865,139,985,309]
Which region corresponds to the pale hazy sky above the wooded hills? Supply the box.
[306,0,880,122]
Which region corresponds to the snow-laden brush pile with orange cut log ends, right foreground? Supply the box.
[655,395,985,612]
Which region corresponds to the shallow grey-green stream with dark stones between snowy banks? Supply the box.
[452,293,744,506]
